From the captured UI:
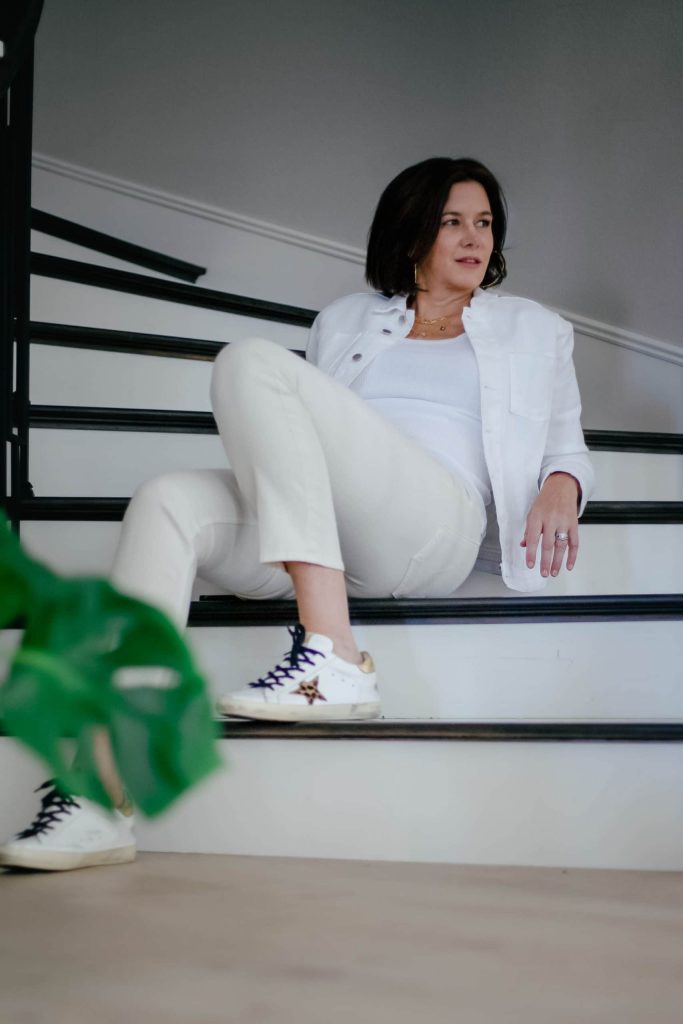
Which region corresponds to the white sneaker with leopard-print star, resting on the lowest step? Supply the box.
[217,624,381,722]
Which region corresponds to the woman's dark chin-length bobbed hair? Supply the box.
[366,157,508,297]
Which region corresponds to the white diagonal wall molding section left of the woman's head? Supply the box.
[33,153,366,264]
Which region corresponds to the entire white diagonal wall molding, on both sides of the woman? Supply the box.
[33,153,683,366]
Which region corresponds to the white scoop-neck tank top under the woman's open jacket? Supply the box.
[350,334,492,515]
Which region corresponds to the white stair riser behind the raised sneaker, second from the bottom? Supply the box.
[2,621,683,722]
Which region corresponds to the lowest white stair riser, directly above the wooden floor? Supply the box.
[0,739,683,871]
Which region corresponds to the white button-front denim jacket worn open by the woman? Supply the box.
[306,288,593,591]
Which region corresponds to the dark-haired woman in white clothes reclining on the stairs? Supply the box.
[0,158,592,866]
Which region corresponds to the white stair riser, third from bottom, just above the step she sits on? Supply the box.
[22,516,683,597]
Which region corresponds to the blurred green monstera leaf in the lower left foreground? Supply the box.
[0,513,220,815]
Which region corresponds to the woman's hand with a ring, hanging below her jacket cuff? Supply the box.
[520,473,581,577]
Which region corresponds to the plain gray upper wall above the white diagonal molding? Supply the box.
[35,0,683,343]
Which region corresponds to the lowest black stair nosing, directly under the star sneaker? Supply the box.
[217,718,683,743]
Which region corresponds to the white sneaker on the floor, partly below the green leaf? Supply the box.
[0,779,135,871]
